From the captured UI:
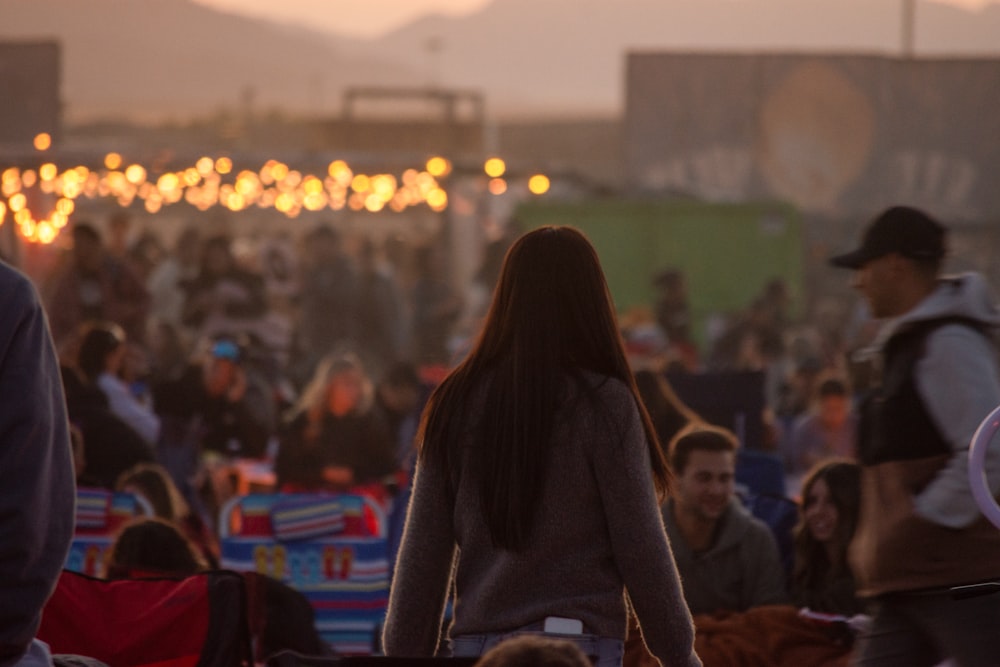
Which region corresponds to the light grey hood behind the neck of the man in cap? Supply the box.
[873,272,1000,348]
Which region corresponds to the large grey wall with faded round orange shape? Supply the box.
[624,53,1000,223]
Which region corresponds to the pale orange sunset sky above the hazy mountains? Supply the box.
[195,0,1000,37]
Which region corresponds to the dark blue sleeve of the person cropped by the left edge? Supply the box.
[0,264,76,667]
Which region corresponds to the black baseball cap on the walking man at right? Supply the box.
[830,206,947,269]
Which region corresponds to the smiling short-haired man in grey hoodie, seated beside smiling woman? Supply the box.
[663,424,788,614]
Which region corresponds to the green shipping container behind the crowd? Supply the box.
[515,200,804,347]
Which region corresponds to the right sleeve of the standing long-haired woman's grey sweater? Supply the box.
[593,391,701,666]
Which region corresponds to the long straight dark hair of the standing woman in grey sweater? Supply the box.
[417,227,670,551]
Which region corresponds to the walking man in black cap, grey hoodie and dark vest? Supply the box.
[830,206,1000,667]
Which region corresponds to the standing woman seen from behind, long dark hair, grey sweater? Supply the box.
[383,227,701,667]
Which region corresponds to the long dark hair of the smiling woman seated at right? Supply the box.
[792,459,861,590]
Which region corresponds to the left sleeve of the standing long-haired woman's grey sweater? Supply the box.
[382,463,457,657]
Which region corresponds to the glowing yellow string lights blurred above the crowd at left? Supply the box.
[0,133,550,244]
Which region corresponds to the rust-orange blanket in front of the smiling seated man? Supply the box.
[624,605,851,667]
